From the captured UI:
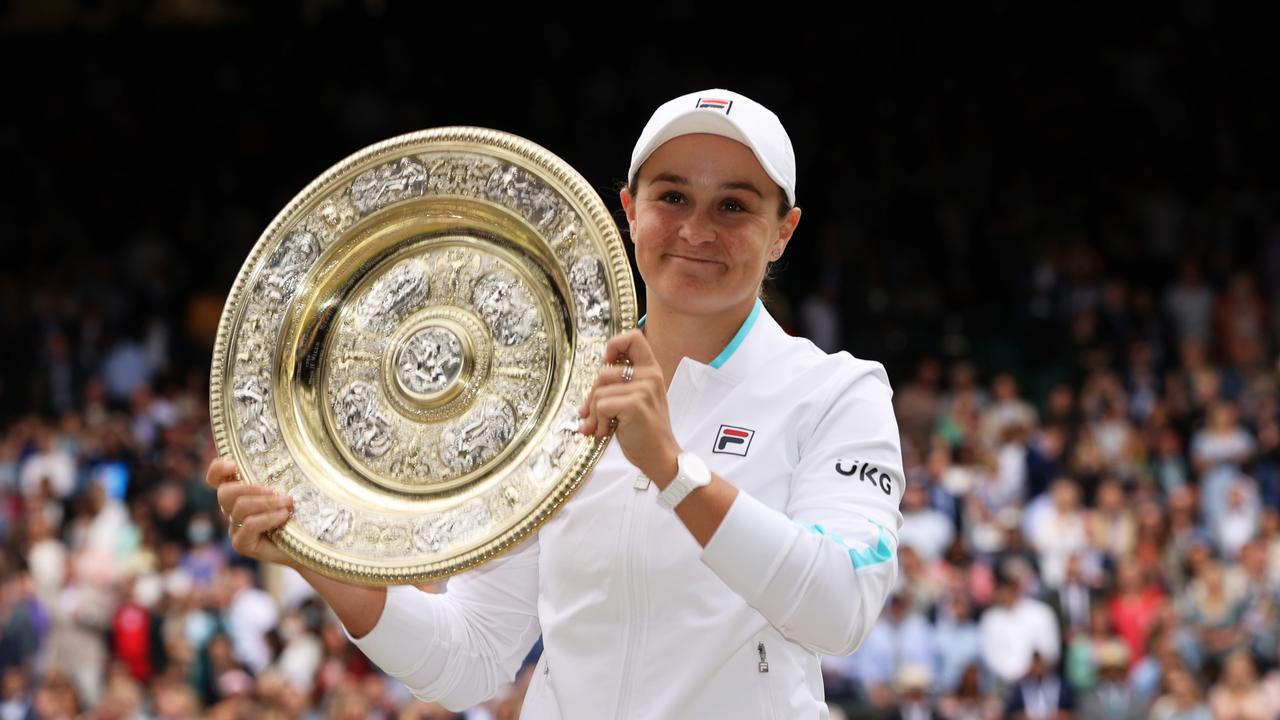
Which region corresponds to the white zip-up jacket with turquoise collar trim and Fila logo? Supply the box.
[344,301,902,720]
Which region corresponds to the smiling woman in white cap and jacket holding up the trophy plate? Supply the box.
[209,90,902,719]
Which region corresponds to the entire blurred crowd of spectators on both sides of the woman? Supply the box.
[0,243,1280,720]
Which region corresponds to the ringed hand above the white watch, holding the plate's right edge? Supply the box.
[577,329,680,480]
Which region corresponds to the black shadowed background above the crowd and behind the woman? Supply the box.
[0,0,1280,414]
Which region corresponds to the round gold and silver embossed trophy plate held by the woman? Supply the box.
[210,127,636,585]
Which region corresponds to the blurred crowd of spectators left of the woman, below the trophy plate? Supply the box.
[0,326,527,720]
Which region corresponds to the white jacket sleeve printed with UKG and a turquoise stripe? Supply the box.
[701,354,904,655]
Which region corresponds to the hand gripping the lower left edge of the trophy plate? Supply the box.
[205,457,293,568]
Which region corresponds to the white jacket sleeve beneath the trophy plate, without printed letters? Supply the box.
[343,536,541,712]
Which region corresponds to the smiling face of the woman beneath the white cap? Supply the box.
[621,133,800,315]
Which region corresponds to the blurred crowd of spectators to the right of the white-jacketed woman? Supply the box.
[824,243,1280,719]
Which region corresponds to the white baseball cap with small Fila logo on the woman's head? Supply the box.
[627,88,796,205]
